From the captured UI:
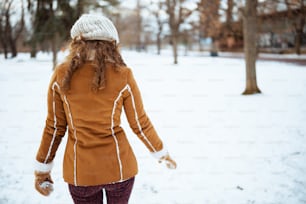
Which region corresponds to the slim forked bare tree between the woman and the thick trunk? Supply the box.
[165,0,192,64]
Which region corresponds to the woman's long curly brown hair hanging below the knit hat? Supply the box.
[61,38,126,92]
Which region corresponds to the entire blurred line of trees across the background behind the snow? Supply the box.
[0,0,306,94]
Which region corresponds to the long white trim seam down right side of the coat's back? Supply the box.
[111,85,128,181]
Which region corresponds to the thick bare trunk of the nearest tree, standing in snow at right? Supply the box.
[242,0,261,95]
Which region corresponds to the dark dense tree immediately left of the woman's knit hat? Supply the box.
[27,0,119,67]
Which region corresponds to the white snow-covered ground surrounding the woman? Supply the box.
[0,51,306,204]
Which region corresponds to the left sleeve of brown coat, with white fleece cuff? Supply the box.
[35,71,67,172]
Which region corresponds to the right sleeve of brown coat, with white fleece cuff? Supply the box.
[123,69,168,159]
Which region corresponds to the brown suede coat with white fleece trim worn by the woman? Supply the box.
[36,63,166,186]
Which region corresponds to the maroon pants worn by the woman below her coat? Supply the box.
[69,177,135,204]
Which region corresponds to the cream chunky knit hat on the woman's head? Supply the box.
[70,14,119,44]
